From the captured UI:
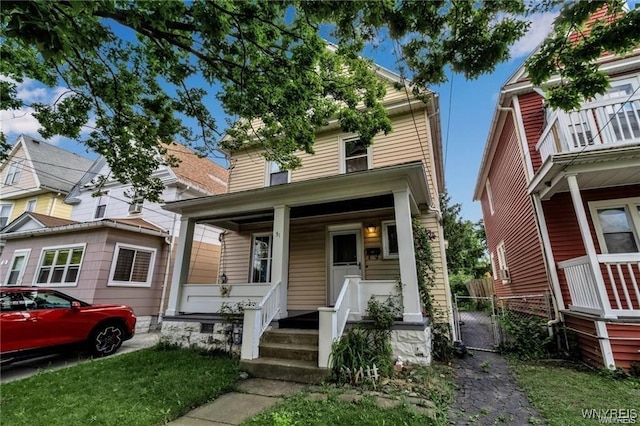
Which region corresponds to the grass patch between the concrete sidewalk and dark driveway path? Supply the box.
[242,365,454,426]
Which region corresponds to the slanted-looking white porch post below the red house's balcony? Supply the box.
[567,175,617,318]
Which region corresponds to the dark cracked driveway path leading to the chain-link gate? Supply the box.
[450,351,546,425]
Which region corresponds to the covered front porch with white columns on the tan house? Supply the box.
[160,163,435,368]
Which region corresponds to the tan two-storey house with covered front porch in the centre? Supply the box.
[162,64,452,379]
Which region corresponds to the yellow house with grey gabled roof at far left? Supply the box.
[0,135,93,229]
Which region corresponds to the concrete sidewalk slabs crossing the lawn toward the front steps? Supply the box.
[168,379,307,426]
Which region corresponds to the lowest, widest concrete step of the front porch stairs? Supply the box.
[240,357,331,384]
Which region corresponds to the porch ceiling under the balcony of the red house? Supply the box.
[529,146,640,200]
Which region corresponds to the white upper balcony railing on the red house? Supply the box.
[536,91,640,162]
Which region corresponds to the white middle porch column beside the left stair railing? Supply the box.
[271,206,291,318]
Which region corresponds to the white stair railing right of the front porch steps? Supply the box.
[318,276,398,368]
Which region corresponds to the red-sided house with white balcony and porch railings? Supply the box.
[474,9,640,368]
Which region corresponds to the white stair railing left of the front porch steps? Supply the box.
[240,282,280,359]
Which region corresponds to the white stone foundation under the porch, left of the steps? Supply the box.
[160,320,240,355]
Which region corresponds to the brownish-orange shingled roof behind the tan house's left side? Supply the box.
[166,143,229,194]
